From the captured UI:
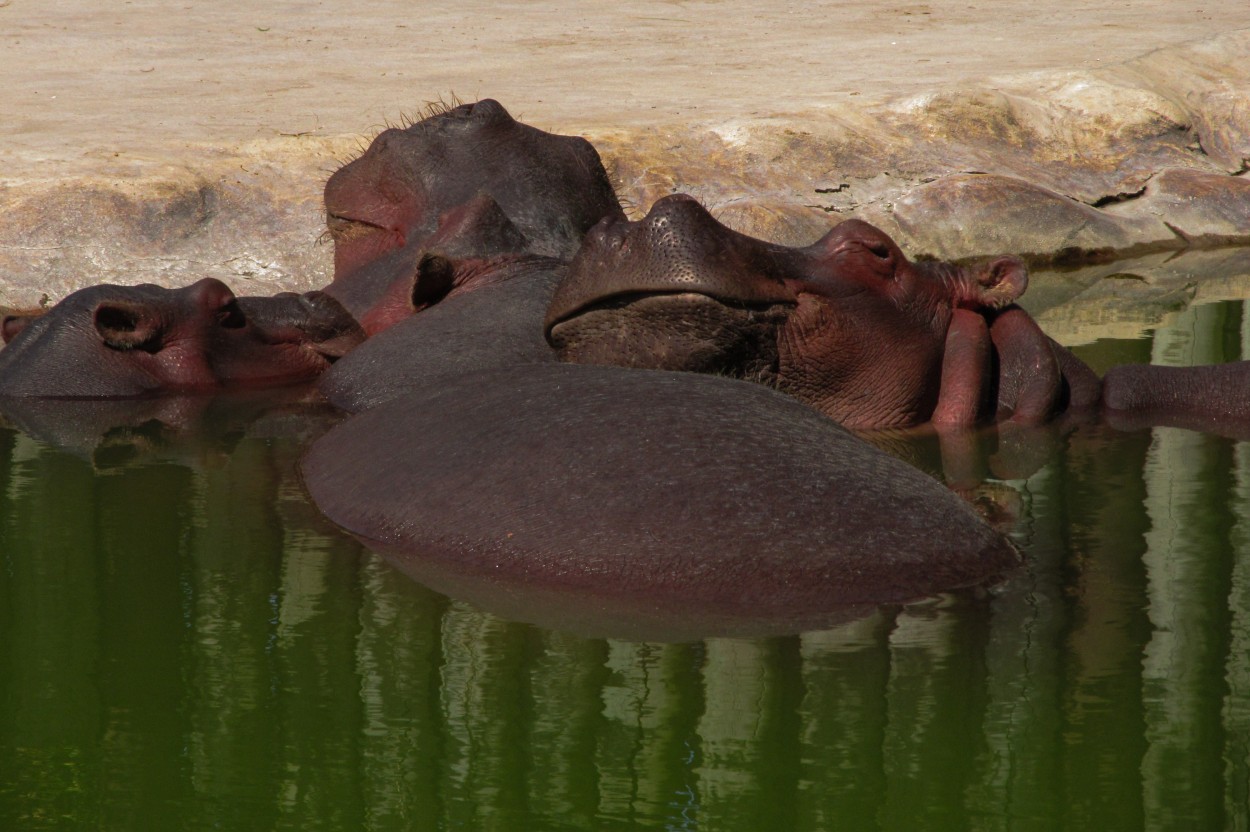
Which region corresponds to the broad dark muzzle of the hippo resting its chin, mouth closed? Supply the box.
[544,195,795,379]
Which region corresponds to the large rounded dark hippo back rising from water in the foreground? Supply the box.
[303,364,1018,635]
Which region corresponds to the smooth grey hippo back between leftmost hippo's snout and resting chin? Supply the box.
[319,257,566,412]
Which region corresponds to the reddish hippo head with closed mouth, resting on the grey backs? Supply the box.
[545,195,1028,427]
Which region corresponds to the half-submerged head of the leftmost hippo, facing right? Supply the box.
[0,277,364,399]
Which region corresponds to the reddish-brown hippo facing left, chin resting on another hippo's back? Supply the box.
[544,195,1250,433]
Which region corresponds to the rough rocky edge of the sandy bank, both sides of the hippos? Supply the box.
[0,30,1250,307]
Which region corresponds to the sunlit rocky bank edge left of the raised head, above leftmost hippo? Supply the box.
[0,146,345,307]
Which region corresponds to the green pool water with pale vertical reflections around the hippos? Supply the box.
[0,304,1250,831]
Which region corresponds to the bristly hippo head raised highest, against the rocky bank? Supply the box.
[325,99,621,277]
